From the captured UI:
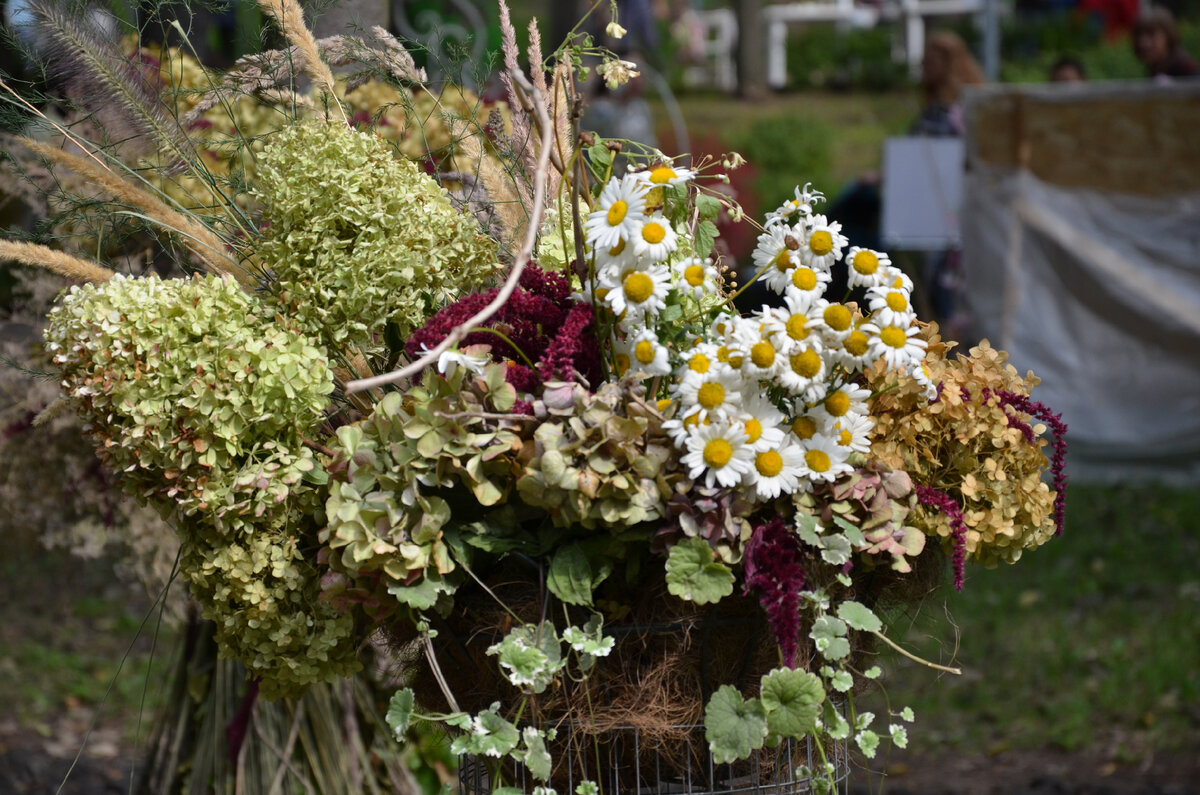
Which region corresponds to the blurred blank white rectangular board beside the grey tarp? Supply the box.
[881,137,965,251]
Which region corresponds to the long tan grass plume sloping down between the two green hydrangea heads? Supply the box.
[20,138,253,287]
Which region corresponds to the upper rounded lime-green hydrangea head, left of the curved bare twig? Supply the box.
[257,124,497,353]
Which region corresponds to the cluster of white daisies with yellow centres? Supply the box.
[584,174,935,501]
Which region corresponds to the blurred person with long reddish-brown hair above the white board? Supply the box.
[910,30,984,137]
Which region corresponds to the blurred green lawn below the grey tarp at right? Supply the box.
[875,486,1200,763]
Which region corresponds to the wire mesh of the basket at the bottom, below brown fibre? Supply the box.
[458,725,850,795]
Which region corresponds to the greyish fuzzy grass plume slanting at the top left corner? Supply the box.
[31,2,193,162]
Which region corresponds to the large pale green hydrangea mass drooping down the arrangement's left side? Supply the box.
[46,276,358,698]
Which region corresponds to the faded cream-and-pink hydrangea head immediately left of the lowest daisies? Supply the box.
[517,383,680,530]
